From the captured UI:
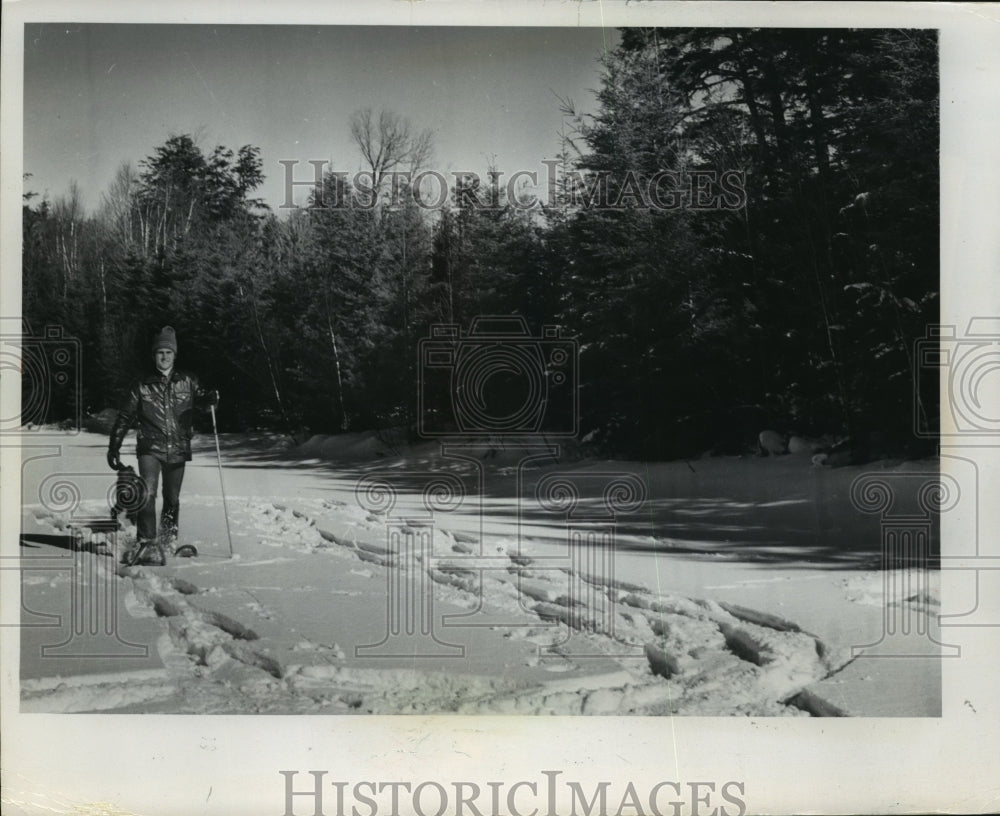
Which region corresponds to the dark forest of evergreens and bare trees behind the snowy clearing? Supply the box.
[23,28,939,458]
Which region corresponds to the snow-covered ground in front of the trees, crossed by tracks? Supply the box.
[21,434,940,716]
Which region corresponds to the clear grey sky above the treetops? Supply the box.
[24,23,617,211]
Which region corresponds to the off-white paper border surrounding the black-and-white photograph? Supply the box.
[0,0,1000,816]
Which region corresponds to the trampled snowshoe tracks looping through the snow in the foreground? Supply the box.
[22,497,920,716]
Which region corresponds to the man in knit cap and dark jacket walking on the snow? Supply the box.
[108,326,219,560]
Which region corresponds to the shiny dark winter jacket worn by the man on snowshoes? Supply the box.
[110,369,211,463]
